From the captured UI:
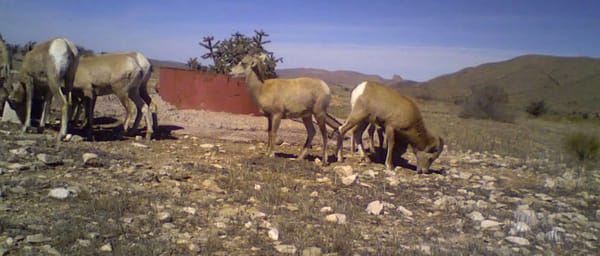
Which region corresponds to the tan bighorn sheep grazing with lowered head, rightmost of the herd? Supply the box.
[337,82,444,173]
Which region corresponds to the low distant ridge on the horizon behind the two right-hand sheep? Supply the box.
[277,68,416,88]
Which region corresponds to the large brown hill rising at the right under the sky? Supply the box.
[403,55,600,113]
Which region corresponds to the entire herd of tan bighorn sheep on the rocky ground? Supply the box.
[0,38,444,173]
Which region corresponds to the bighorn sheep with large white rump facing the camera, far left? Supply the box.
[9,38,79,140]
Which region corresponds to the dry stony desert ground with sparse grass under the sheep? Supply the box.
[0,79,600,255]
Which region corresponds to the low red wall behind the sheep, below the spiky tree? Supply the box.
[159,67,259,114]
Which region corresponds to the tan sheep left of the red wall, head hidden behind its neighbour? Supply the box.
[73,54,152,139]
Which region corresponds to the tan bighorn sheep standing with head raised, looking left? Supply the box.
[230,55,331,165]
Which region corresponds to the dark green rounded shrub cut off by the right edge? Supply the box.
[564,132,600,162]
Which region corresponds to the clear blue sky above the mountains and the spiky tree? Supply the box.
[0,0,600,81]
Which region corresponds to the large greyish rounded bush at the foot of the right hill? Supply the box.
[460,85,514,122]
